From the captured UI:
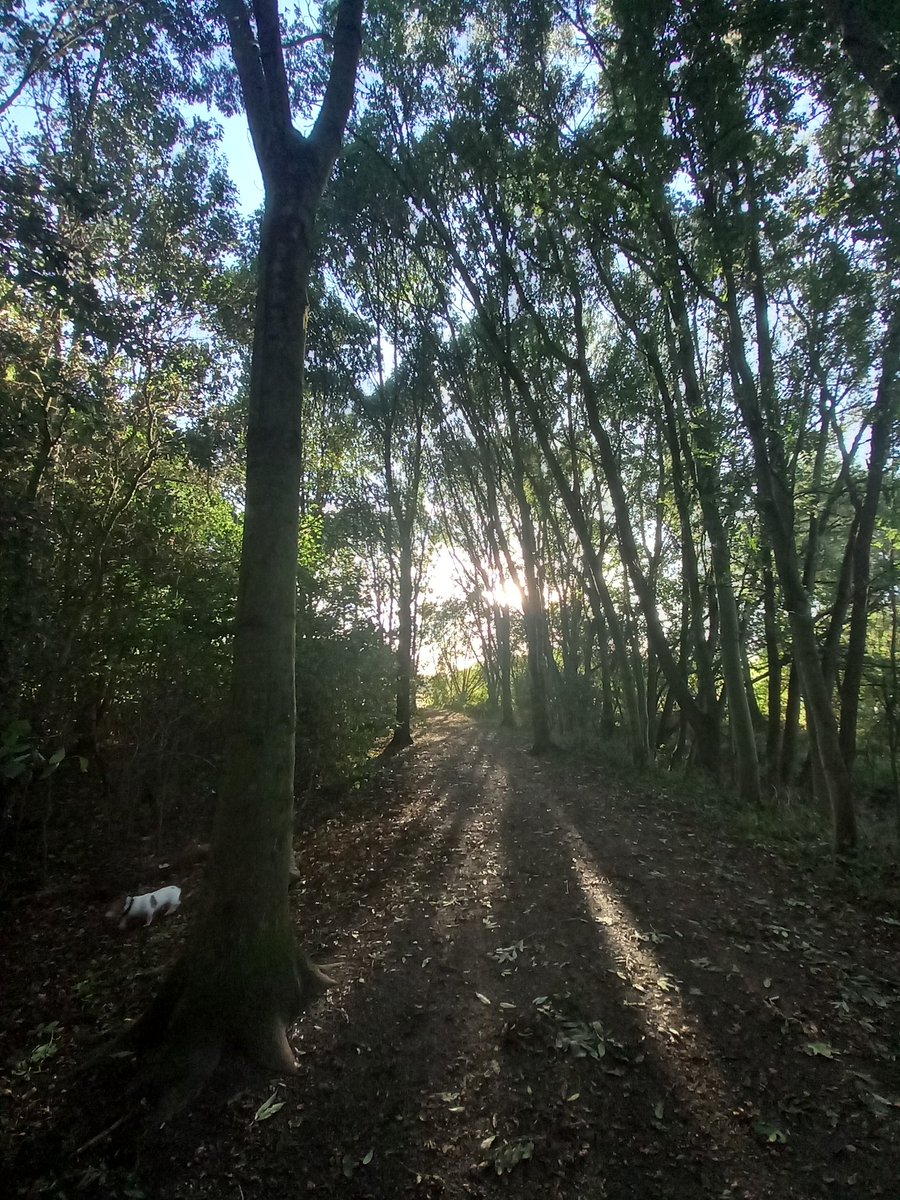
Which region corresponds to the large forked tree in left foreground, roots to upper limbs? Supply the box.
[130,0,362,1117]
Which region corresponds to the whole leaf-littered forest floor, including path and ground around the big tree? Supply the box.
[0,715,900,1200]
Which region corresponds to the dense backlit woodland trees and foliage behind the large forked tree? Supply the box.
[0,0,900,868]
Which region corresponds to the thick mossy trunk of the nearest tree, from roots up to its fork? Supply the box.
[128,193,320,1111]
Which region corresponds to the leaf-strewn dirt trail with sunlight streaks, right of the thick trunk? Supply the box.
[277,715,900,1200]
